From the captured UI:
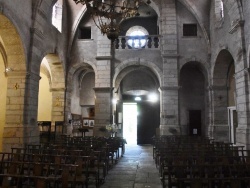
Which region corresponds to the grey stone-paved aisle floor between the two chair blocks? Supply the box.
[97,145,162,188]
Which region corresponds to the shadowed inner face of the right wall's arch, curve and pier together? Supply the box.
[211,49,235,141]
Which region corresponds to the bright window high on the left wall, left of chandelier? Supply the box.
[52,0,63,32]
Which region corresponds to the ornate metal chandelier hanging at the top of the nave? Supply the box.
[73,0,151,41]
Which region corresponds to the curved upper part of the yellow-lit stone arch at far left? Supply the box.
[0,14,26,72]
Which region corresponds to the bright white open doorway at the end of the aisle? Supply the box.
[123,103,137,145]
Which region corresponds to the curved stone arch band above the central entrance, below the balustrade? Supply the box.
[113,58,162,88]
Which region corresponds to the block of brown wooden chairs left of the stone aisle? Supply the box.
[0,137,125,188]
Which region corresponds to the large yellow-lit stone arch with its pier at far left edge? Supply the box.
[0,13,27,151]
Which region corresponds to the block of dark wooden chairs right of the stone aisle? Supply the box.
[153,136,250,188]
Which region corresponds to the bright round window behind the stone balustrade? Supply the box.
[126,26,148,48]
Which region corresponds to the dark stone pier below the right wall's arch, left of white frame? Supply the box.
[211,86,229,142]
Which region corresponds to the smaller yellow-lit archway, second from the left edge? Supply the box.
[37,53,65,130]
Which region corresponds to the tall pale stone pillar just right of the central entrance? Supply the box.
[160,0,180,135]
